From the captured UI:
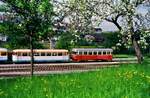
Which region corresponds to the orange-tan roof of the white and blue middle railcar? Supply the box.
[13,49,68,52]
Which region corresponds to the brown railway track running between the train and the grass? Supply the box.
[0,59,137,77]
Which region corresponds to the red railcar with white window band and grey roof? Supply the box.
[71,48,113,62]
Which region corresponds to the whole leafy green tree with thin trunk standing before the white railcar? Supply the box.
[0,0,54,75]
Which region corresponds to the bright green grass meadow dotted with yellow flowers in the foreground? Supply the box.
[0,58,150,98]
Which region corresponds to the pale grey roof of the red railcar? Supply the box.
[72,48,113,52]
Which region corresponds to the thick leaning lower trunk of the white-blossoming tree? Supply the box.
[132,38,143,63]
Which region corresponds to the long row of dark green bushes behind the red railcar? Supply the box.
[56,32,143,54]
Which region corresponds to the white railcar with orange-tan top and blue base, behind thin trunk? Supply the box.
[12,49,69,62]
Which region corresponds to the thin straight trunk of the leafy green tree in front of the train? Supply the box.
[30,32,34,76]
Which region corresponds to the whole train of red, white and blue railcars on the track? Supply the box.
[0,48,113,63]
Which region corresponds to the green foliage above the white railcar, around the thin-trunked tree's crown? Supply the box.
[2,0,54,48]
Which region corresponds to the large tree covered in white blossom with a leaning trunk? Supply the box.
[55,0,150,63]
